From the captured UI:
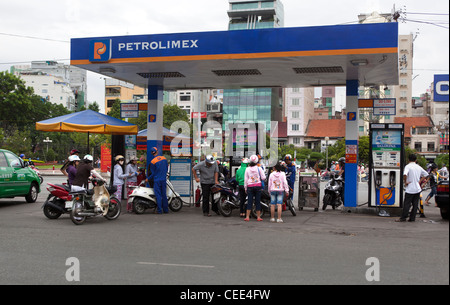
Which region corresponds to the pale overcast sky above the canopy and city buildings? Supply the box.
[0,0,449,113]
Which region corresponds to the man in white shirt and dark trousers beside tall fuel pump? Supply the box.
[396,154,428,222]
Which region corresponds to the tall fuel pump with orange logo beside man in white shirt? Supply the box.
[369,124,404,208]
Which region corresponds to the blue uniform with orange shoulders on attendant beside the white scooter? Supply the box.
[147,156,169,214]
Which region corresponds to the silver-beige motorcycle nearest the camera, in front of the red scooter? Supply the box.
[70,178,122,225]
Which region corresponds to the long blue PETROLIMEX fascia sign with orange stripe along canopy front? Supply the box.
[71,23,398,64]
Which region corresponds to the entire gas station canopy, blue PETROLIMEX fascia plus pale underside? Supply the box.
[71,23,398,90]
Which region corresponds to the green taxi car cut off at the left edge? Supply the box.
[0,149,41,203]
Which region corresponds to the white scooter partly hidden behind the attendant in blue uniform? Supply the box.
[128,179,183,214]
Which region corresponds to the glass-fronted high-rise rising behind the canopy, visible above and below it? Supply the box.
[223,0,284,130]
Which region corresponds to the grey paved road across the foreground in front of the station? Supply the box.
[0,177,449,285]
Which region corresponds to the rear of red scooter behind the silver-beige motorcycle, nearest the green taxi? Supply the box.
[42,183,72,219]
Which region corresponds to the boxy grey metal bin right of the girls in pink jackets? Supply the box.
[298,176,320,212]
